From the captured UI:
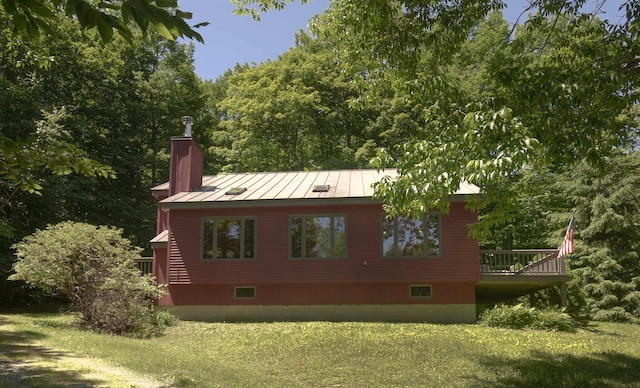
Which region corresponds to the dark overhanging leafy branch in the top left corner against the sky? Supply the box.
[2,0,203,42]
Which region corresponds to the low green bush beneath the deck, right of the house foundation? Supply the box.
[479,304,578,332]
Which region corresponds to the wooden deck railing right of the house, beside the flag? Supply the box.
[480,249,564,275]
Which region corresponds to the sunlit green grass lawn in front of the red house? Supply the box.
[0,314,640,387]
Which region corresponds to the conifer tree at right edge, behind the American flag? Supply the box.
[556,152,640,323]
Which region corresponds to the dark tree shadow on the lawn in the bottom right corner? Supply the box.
[473,352,640,388]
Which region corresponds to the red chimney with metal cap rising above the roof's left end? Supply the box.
[169,116,204,196]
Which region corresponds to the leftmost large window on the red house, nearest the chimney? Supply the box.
[202,218,256,260]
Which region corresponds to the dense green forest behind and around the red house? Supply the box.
[0,1,640,322]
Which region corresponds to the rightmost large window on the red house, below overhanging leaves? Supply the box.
[382,213,441,257]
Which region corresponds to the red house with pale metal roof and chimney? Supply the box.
[151,131,568,322]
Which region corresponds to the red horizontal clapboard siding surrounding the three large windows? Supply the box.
[169,202,480,288]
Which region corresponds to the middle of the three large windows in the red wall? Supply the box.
[289,216,347,259]
